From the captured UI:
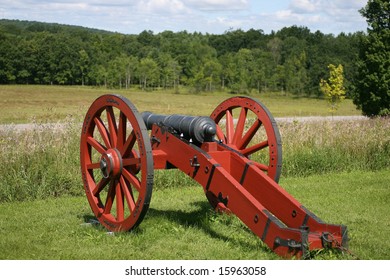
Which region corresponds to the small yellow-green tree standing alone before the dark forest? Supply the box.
[320,64,345,116]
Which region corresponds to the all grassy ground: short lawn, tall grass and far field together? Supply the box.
[0,86,390,259]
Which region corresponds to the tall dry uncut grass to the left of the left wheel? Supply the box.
[0,119,83,202]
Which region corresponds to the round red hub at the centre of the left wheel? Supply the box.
[100,149,123,178]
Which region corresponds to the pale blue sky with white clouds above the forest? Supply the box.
[0,0,367,35]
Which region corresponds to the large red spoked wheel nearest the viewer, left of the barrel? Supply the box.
[80,95,153,231]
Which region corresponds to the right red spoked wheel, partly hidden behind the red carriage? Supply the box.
[210,96,282,182]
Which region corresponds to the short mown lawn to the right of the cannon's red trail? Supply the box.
[282,169,390,260]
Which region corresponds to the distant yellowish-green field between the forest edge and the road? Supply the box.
[0,85,360,124]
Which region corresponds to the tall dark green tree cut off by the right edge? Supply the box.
[353,0,390,116]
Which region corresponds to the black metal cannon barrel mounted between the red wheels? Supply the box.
[141,112,217,143]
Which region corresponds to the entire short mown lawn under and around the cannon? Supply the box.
[0,170,390,260]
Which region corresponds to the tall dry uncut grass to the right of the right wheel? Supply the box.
[279,118,390,176]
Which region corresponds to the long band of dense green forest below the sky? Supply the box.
[0,19,367,96]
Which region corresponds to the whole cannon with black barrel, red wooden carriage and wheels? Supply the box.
[80,94,348,258]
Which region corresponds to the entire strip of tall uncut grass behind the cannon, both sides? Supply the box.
[0,119,390,202]
